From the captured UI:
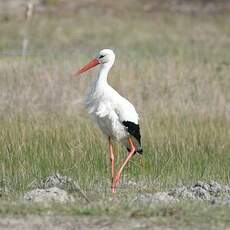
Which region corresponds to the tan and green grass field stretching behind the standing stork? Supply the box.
[0,3,230,228]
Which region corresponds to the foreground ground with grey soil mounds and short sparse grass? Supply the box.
[0,174,230,229]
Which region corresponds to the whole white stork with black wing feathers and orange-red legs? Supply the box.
[73,49,143,193]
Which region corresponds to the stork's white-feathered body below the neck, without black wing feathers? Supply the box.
[85,72,139,152]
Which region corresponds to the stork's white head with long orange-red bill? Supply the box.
[73,49,115,75]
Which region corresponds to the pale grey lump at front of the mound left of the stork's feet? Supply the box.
[22,187,74,203]
